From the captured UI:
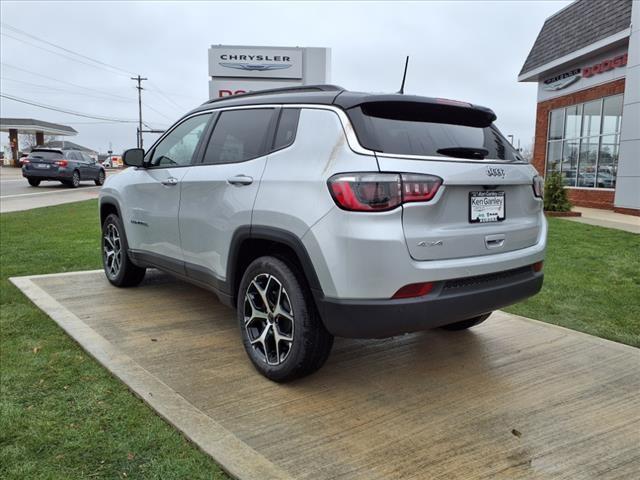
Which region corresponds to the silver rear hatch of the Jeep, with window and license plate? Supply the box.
[350,101,543,260]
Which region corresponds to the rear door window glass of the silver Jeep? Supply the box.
[203,108,274,164]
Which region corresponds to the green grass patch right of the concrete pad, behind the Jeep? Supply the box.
[506,218,640,347]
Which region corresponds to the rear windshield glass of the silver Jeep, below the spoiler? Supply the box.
[350,103,523,162]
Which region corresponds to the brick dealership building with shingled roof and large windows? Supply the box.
[518,0,640,215]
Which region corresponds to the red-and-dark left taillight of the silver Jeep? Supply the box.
[327,173,442,212]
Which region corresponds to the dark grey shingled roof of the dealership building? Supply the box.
[520,0,631,75]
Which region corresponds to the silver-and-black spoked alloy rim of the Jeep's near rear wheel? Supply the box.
[244,273,294,365]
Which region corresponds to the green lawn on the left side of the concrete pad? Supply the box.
[0,200,228,479]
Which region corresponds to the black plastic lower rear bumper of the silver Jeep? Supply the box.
[316,266,544,338]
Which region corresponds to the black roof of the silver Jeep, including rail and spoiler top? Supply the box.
[190,85,496,120]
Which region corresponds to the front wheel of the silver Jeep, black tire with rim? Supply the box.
[101,213,146,287]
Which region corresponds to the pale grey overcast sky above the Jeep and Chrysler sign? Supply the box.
[0,0,570,152]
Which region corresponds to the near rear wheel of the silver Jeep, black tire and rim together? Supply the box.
[237,256,333,382]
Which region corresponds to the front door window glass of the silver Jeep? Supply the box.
[149,113,211,167]
